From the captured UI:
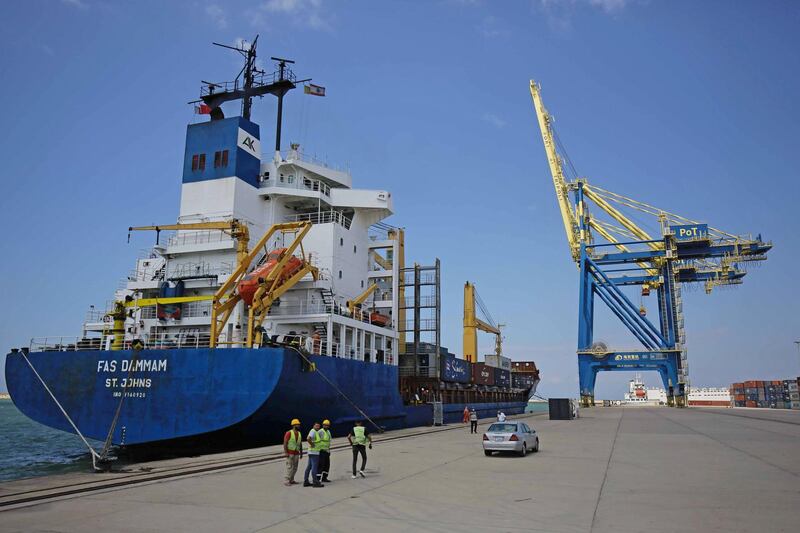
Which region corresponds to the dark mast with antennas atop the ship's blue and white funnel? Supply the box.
[200,35,311,154]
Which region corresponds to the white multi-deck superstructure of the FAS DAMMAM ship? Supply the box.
[79,143,403,364]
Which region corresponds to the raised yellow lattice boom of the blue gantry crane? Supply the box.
[531,80,581,261]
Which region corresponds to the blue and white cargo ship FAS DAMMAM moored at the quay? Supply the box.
[5,38,539,450]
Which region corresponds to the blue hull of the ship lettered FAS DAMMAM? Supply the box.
[5,347,526,447]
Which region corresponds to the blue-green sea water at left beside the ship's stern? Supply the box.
[0,399,102,481]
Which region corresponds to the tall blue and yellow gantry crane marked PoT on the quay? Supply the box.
[530,80,772,407]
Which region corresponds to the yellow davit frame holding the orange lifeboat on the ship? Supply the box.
[210,222,319,348]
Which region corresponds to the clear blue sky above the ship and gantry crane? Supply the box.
[0,0,800,398]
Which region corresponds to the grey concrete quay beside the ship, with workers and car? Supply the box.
[0,407,800,533]
